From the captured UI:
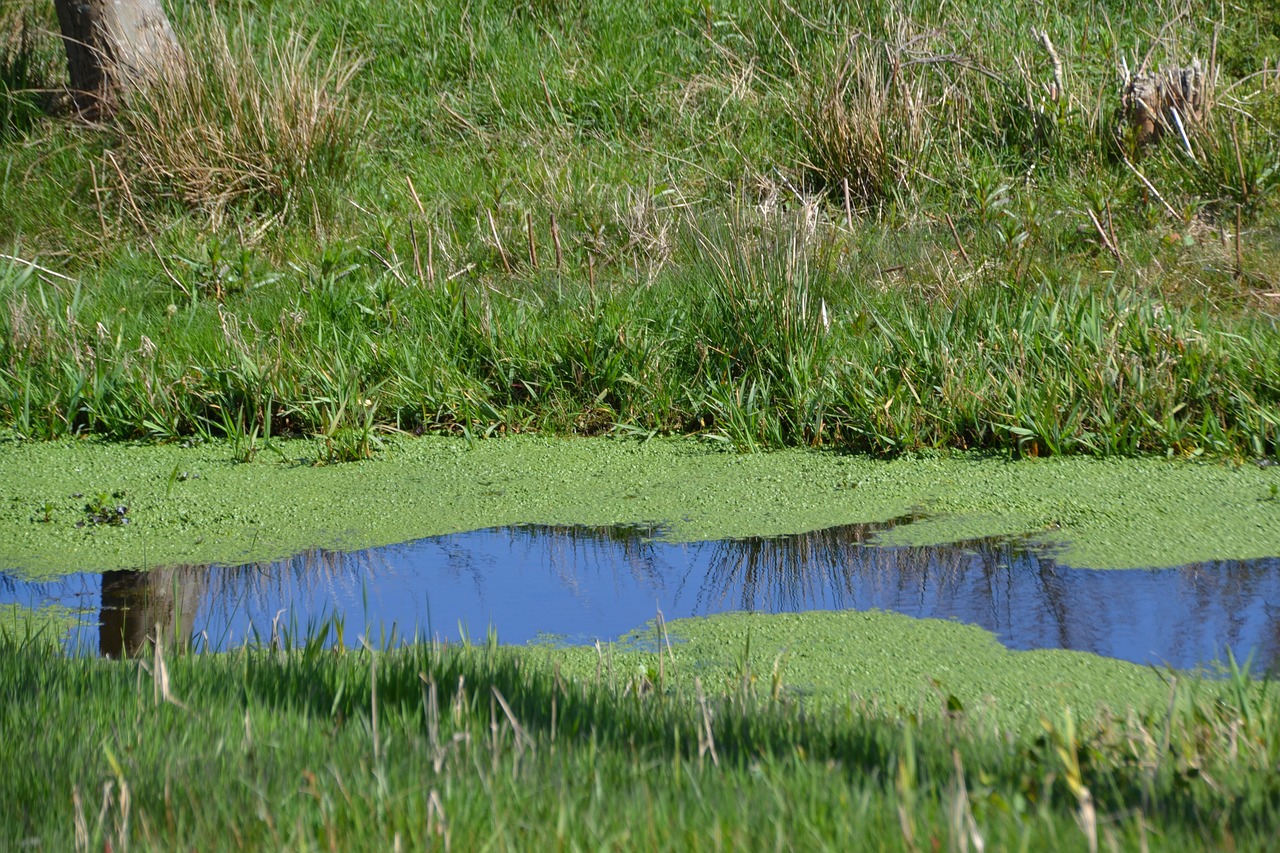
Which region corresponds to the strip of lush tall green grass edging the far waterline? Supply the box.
[0,203,1280,461]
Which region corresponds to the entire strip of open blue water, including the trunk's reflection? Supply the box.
[0,523,1280,671]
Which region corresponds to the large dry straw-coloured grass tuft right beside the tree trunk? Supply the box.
[108,9,365,225]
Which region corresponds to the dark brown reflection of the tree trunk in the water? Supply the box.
[99,566,209,657]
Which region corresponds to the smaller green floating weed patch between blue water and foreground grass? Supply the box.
[530,611,1182,729]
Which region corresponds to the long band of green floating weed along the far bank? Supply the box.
[0,437,1280,576]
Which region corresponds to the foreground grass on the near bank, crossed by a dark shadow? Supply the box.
[0,622,1280,850]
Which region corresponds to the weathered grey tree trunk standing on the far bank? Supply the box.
[54,0,182,118]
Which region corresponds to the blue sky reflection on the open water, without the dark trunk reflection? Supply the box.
[0,528,1280,667]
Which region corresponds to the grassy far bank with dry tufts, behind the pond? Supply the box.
[0,0,1280,461]
